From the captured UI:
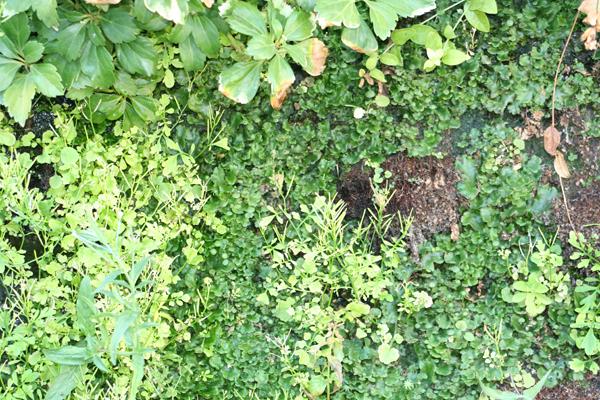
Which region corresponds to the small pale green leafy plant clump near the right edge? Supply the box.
[502,241,570,317]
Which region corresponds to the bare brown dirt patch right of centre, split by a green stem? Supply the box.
[338,153,460,256]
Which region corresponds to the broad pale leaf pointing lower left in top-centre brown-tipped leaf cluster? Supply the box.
[219,61,262,104]
